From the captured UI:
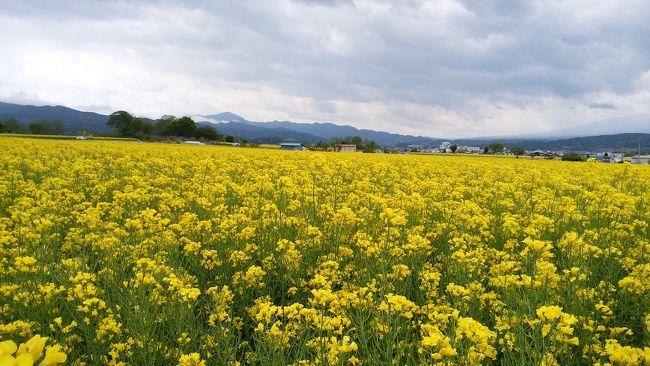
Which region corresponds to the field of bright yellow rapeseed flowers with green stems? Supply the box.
[0,138,650,365]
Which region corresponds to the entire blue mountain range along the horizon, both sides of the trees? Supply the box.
[0,102,650,151]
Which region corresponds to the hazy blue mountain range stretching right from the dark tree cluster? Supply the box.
[192,112,650,151]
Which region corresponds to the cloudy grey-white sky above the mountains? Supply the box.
[0,0,650,137]
